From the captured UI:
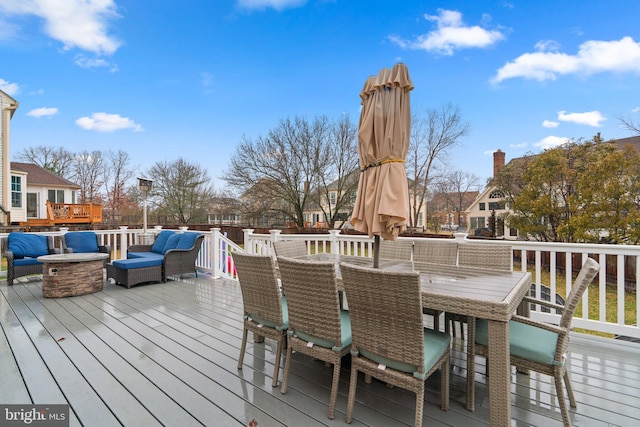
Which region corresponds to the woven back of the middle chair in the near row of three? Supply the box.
[278,256,342,347]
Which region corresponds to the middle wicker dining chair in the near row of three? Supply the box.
[278,257,351,419]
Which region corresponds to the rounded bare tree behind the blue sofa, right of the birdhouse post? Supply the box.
[148,158,215,224]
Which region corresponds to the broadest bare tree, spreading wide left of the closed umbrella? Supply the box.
[224,116,330,227]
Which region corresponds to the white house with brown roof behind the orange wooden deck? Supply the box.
[10,162,80,223]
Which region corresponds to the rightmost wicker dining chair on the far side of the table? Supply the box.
[444,243,513,340]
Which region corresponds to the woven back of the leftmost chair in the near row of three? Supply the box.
[232,252,282,325]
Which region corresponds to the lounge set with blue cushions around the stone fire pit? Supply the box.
[2,230,204,297]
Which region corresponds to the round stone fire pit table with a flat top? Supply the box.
[38,253,109,298]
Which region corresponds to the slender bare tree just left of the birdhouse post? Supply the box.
[102,150,136,221]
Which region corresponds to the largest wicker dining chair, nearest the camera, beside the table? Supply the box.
[340,263,451,426]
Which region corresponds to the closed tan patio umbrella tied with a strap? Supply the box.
[351,63,413,267]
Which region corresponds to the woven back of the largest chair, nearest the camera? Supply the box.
[340,263,424,371]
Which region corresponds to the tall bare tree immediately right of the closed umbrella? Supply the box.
[406,104,469,227]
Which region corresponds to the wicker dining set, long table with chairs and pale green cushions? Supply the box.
[233,241,599,426]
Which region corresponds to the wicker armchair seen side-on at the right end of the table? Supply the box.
[467,258,600,426]
